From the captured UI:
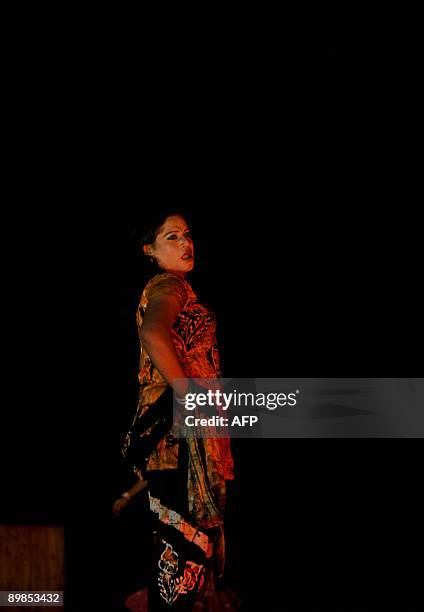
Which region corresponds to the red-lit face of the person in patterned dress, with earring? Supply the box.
[143,215,194,277]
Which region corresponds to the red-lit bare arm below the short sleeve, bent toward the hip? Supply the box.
[141,293,188,396]
